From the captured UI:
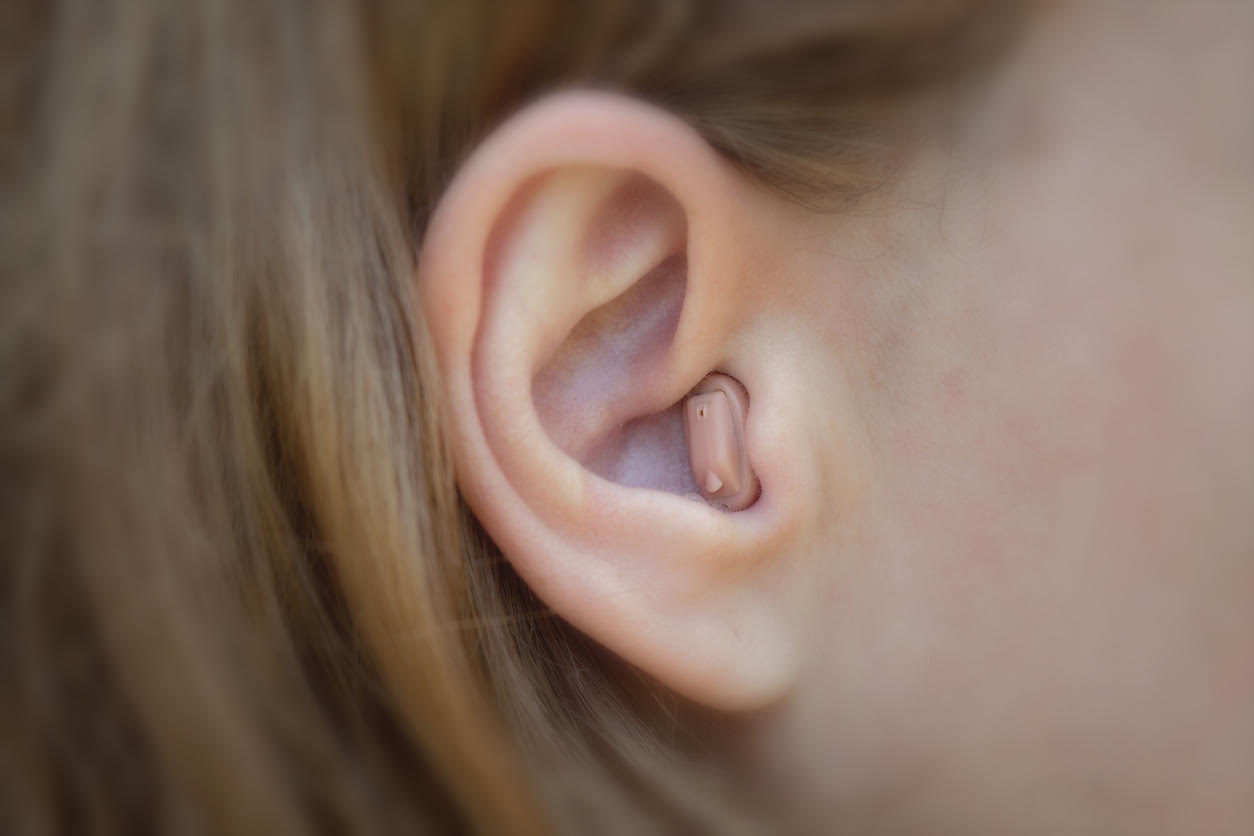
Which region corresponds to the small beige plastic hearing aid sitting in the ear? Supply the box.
[683,372,759,511]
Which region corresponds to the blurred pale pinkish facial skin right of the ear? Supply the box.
[737,3,1254,833]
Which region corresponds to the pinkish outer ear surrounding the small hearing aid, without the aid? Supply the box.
[419,93,798,708]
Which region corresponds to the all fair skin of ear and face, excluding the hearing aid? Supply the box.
[418,0,1254,833]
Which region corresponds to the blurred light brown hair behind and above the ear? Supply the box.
[0,0,1013,833]
